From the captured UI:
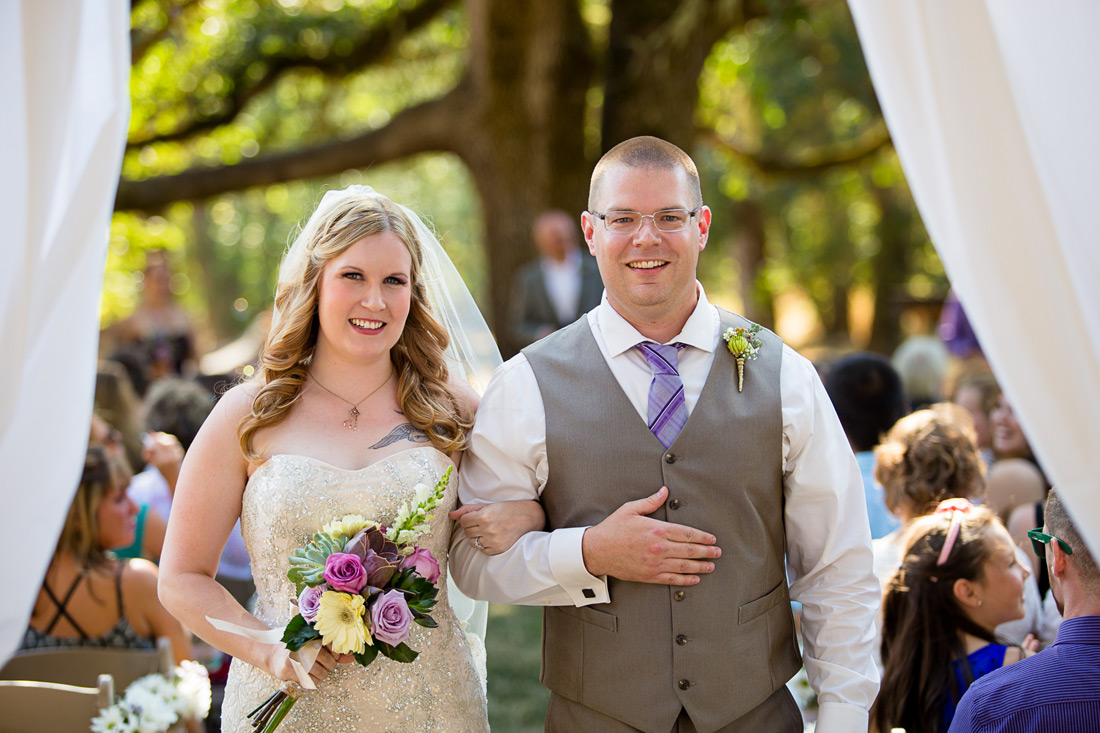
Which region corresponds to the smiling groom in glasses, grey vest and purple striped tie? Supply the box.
[451,138,878,733]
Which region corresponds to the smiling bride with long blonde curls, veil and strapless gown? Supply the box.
[160,186,542,732]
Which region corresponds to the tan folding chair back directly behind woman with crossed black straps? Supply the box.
[0,636,175,693]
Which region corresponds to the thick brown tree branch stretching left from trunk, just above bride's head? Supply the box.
[114,84,469,211]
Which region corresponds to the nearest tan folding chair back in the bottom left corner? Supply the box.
[0,675,114,733]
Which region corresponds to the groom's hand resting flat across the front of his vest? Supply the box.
[581,486,722,586]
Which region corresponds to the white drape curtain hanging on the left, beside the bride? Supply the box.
[0,0,130,664]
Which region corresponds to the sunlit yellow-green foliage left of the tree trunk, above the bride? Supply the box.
[112,0,487,349]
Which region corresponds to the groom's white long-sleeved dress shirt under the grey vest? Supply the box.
[450,285,879,733]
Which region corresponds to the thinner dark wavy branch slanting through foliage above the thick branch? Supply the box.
[127,0,455,150]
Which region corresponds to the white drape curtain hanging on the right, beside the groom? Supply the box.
[848,0,1100,557]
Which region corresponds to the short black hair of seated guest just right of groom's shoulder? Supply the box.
[825,352,908,452]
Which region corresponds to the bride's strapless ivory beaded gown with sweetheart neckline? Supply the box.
[221,446,488,733]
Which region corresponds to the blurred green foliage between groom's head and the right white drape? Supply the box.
[696,2,946,332]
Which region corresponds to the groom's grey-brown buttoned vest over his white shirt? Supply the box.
[524,309,801,733]
